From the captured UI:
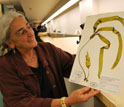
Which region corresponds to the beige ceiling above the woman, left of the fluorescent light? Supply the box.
[0,0,69,22]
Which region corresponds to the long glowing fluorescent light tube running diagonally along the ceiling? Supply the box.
[41,0,79,25]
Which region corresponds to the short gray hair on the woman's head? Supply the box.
[0,10,24,55]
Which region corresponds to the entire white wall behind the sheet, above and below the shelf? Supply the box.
[43,0,124,53]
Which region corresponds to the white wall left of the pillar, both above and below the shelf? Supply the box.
[42,4,81,54]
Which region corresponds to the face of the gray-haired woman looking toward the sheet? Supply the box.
[10,16,37,50]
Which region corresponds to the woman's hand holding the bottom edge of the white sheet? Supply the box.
[65,87,100,106]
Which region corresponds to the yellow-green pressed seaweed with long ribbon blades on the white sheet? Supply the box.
[78,16,124,82]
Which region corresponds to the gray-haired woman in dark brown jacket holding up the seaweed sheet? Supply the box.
[0,11,99,107]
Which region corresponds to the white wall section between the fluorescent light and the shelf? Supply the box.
[47,4,80,34]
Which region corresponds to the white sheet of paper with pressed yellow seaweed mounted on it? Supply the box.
[69,12,124,95]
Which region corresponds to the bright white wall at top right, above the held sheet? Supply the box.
[79,0,124,23]
